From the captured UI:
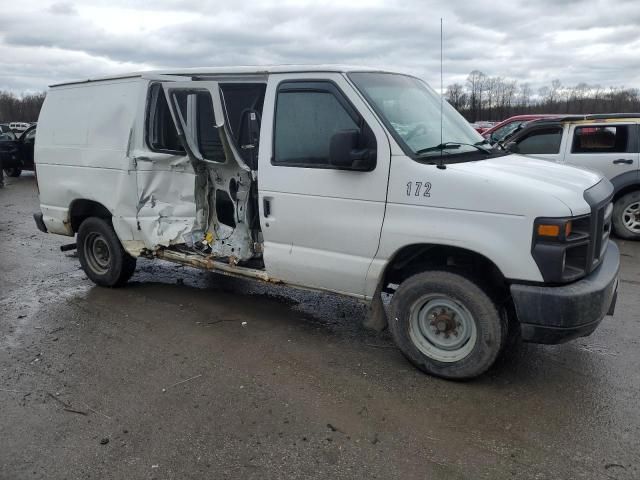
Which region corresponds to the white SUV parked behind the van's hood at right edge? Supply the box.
[505,113,640,240]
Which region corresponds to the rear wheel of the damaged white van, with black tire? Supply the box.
[77,217,136,287]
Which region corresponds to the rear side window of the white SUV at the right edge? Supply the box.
[571,125,632,153]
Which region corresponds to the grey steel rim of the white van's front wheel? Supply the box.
[409,294,478,362]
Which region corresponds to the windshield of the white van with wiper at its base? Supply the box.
[349,73,483,158]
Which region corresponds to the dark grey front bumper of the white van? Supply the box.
[511,241,620,343]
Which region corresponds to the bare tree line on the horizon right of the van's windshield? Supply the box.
[445,70,640,122]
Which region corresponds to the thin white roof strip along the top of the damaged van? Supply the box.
[49,65,398,87]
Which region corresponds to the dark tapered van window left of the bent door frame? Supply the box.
[147,84,184,153]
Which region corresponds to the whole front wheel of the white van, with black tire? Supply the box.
[389,271,508,380]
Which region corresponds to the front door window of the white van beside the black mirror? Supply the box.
[272,82,375,168]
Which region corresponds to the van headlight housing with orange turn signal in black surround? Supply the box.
[531,215,591,283]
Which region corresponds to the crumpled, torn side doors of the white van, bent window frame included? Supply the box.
[132,82,259,261]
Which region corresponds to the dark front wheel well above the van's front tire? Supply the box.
[381,244,508,294]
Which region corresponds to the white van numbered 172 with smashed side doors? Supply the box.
[35,66,619,378]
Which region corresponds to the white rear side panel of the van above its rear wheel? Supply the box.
[35,79,141,241]
